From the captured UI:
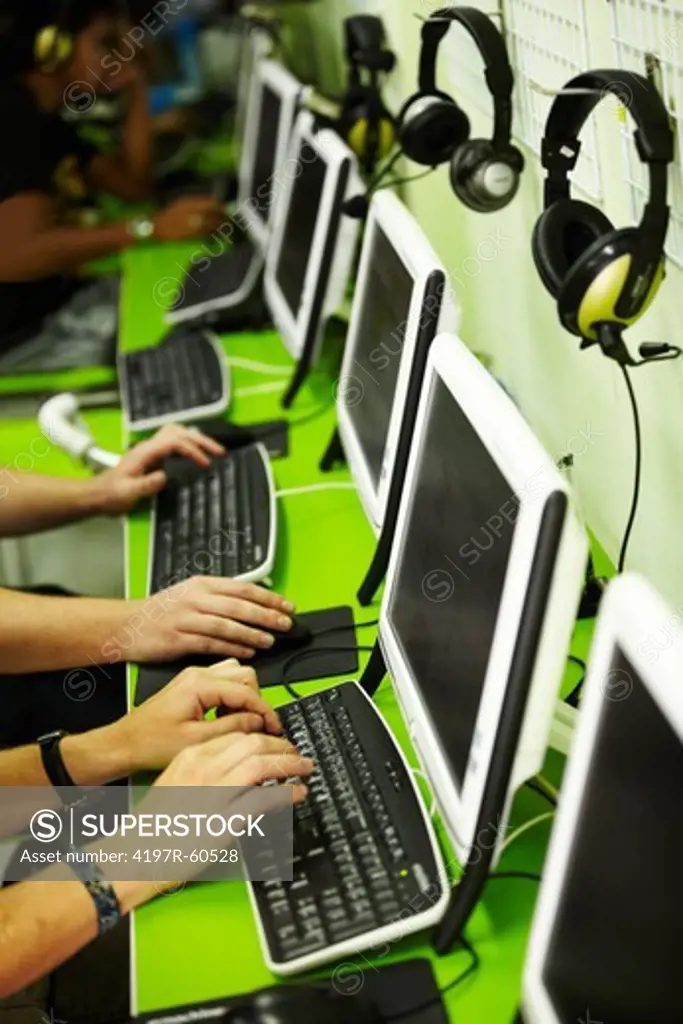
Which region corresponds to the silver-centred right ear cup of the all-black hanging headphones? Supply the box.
[451,138,519,213]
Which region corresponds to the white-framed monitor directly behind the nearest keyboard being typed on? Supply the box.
[380,335,587,861]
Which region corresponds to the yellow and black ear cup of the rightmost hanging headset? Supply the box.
[557,227,664,341]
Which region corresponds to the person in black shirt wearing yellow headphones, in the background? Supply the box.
[0,0,225,373]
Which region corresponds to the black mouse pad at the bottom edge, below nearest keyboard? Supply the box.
[132,959,449,1024]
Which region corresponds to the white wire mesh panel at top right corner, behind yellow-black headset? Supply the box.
[612,0,683,266]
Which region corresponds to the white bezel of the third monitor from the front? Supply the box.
[337,190,460,532]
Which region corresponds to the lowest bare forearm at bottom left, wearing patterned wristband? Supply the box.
[0,869,156,997]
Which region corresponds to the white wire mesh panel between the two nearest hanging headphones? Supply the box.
[503,0,602,199]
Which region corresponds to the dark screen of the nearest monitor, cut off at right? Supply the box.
[544,651,683,1024]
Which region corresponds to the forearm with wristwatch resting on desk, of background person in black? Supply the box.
[0,221,134,282]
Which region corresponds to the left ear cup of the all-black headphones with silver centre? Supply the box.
[399,94,470,167]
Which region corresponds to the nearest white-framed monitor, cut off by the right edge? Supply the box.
[524,575,683,1024]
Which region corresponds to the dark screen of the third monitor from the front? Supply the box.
[348,227,414,490]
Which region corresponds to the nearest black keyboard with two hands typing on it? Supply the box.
[252,683,445,974]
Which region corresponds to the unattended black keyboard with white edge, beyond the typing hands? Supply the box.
[119,328,229,430]
